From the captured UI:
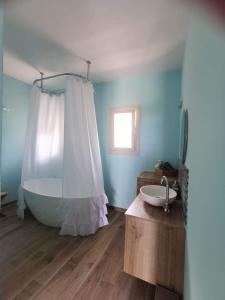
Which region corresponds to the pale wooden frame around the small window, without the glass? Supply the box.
[109,106,140,155]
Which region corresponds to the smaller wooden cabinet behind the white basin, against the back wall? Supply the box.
[136,171,177,195]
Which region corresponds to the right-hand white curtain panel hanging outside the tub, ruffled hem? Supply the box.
[59,78,108,235]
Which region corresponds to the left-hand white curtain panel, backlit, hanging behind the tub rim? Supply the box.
[21,86,64,182]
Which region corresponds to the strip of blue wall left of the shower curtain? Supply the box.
[2,76,31,203]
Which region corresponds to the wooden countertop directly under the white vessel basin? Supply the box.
[125,194,185,228]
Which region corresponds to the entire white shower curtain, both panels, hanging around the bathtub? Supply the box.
[18,77,108,235]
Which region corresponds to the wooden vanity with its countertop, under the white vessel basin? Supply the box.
[124,195,185,294]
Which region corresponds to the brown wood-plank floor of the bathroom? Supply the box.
[0,205,154,300]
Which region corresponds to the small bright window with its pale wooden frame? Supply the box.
[109,107,139,154]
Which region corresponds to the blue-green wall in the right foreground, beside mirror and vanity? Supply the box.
[182,13,225,300]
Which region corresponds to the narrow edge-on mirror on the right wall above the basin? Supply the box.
[180,109,188,165]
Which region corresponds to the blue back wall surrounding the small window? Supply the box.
[94,71,181,208]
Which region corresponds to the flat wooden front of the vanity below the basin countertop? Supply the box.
[124,216,185,293]
